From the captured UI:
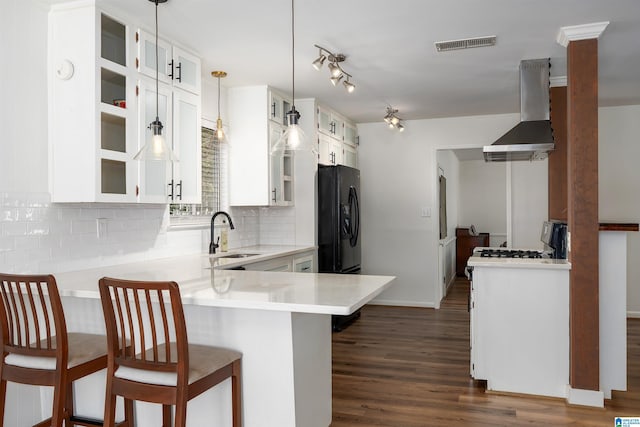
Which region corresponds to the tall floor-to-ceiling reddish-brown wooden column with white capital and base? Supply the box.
[567,38,600,390]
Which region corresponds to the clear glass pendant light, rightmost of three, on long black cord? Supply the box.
[271,0,318,155]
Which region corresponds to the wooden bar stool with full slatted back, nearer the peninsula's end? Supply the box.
[99,277,242,427]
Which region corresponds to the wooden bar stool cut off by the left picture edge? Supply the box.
[0,274,131,427]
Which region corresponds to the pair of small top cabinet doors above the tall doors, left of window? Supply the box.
[136,30,201,94]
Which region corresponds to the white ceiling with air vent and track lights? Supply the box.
[67,0,640,123]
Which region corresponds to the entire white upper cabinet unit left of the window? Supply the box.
[49,2,201,203]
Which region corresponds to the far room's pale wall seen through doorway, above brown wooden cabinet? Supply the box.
[458,160,508,246]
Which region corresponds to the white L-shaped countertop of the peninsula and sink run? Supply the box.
[55,251,395,315]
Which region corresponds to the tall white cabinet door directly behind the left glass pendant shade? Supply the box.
[138,79,173,203]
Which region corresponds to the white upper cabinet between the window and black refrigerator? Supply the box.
[228,86,294,206]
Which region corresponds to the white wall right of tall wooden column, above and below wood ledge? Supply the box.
[598,105,640,317]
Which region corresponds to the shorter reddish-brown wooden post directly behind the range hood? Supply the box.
[548,86,569,221]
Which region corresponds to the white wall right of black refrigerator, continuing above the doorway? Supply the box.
[358,114,519,307]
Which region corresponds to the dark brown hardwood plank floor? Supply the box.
[331,279,640,427]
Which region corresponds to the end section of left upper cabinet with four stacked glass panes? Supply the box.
[49,4,138,202]
